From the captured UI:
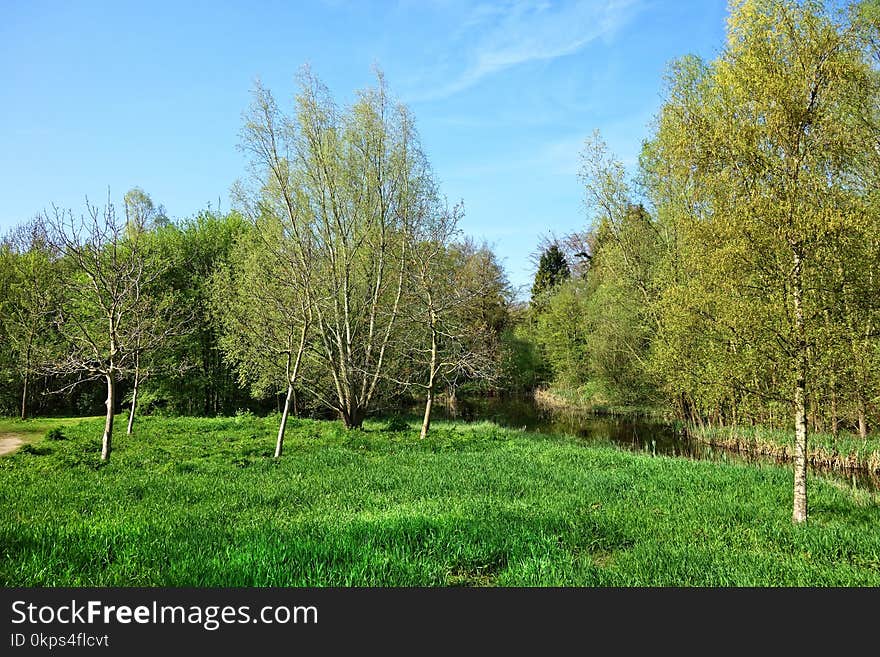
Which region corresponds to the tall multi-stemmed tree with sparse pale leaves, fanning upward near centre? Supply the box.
[242,70,433,428]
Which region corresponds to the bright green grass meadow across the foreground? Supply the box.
[0,415,880,587]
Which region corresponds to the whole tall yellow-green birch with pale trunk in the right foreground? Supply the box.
[657,0,874,522]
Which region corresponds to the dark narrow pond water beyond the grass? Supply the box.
[422,396,880,491]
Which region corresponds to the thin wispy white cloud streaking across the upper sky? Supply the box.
[410,0,641,100]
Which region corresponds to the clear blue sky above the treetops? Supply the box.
[0,0,727,286]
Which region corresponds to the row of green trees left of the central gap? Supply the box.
[0,71,523,458]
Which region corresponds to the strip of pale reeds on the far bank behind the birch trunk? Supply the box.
[688,426,880,476]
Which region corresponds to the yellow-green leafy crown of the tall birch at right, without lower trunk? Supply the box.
[643,0,880,436]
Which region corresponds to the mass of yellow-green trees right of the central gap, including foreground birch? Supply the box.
[533,0,880,520]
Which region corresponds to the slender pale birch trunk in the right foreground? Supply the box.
[791,247,807,523]
